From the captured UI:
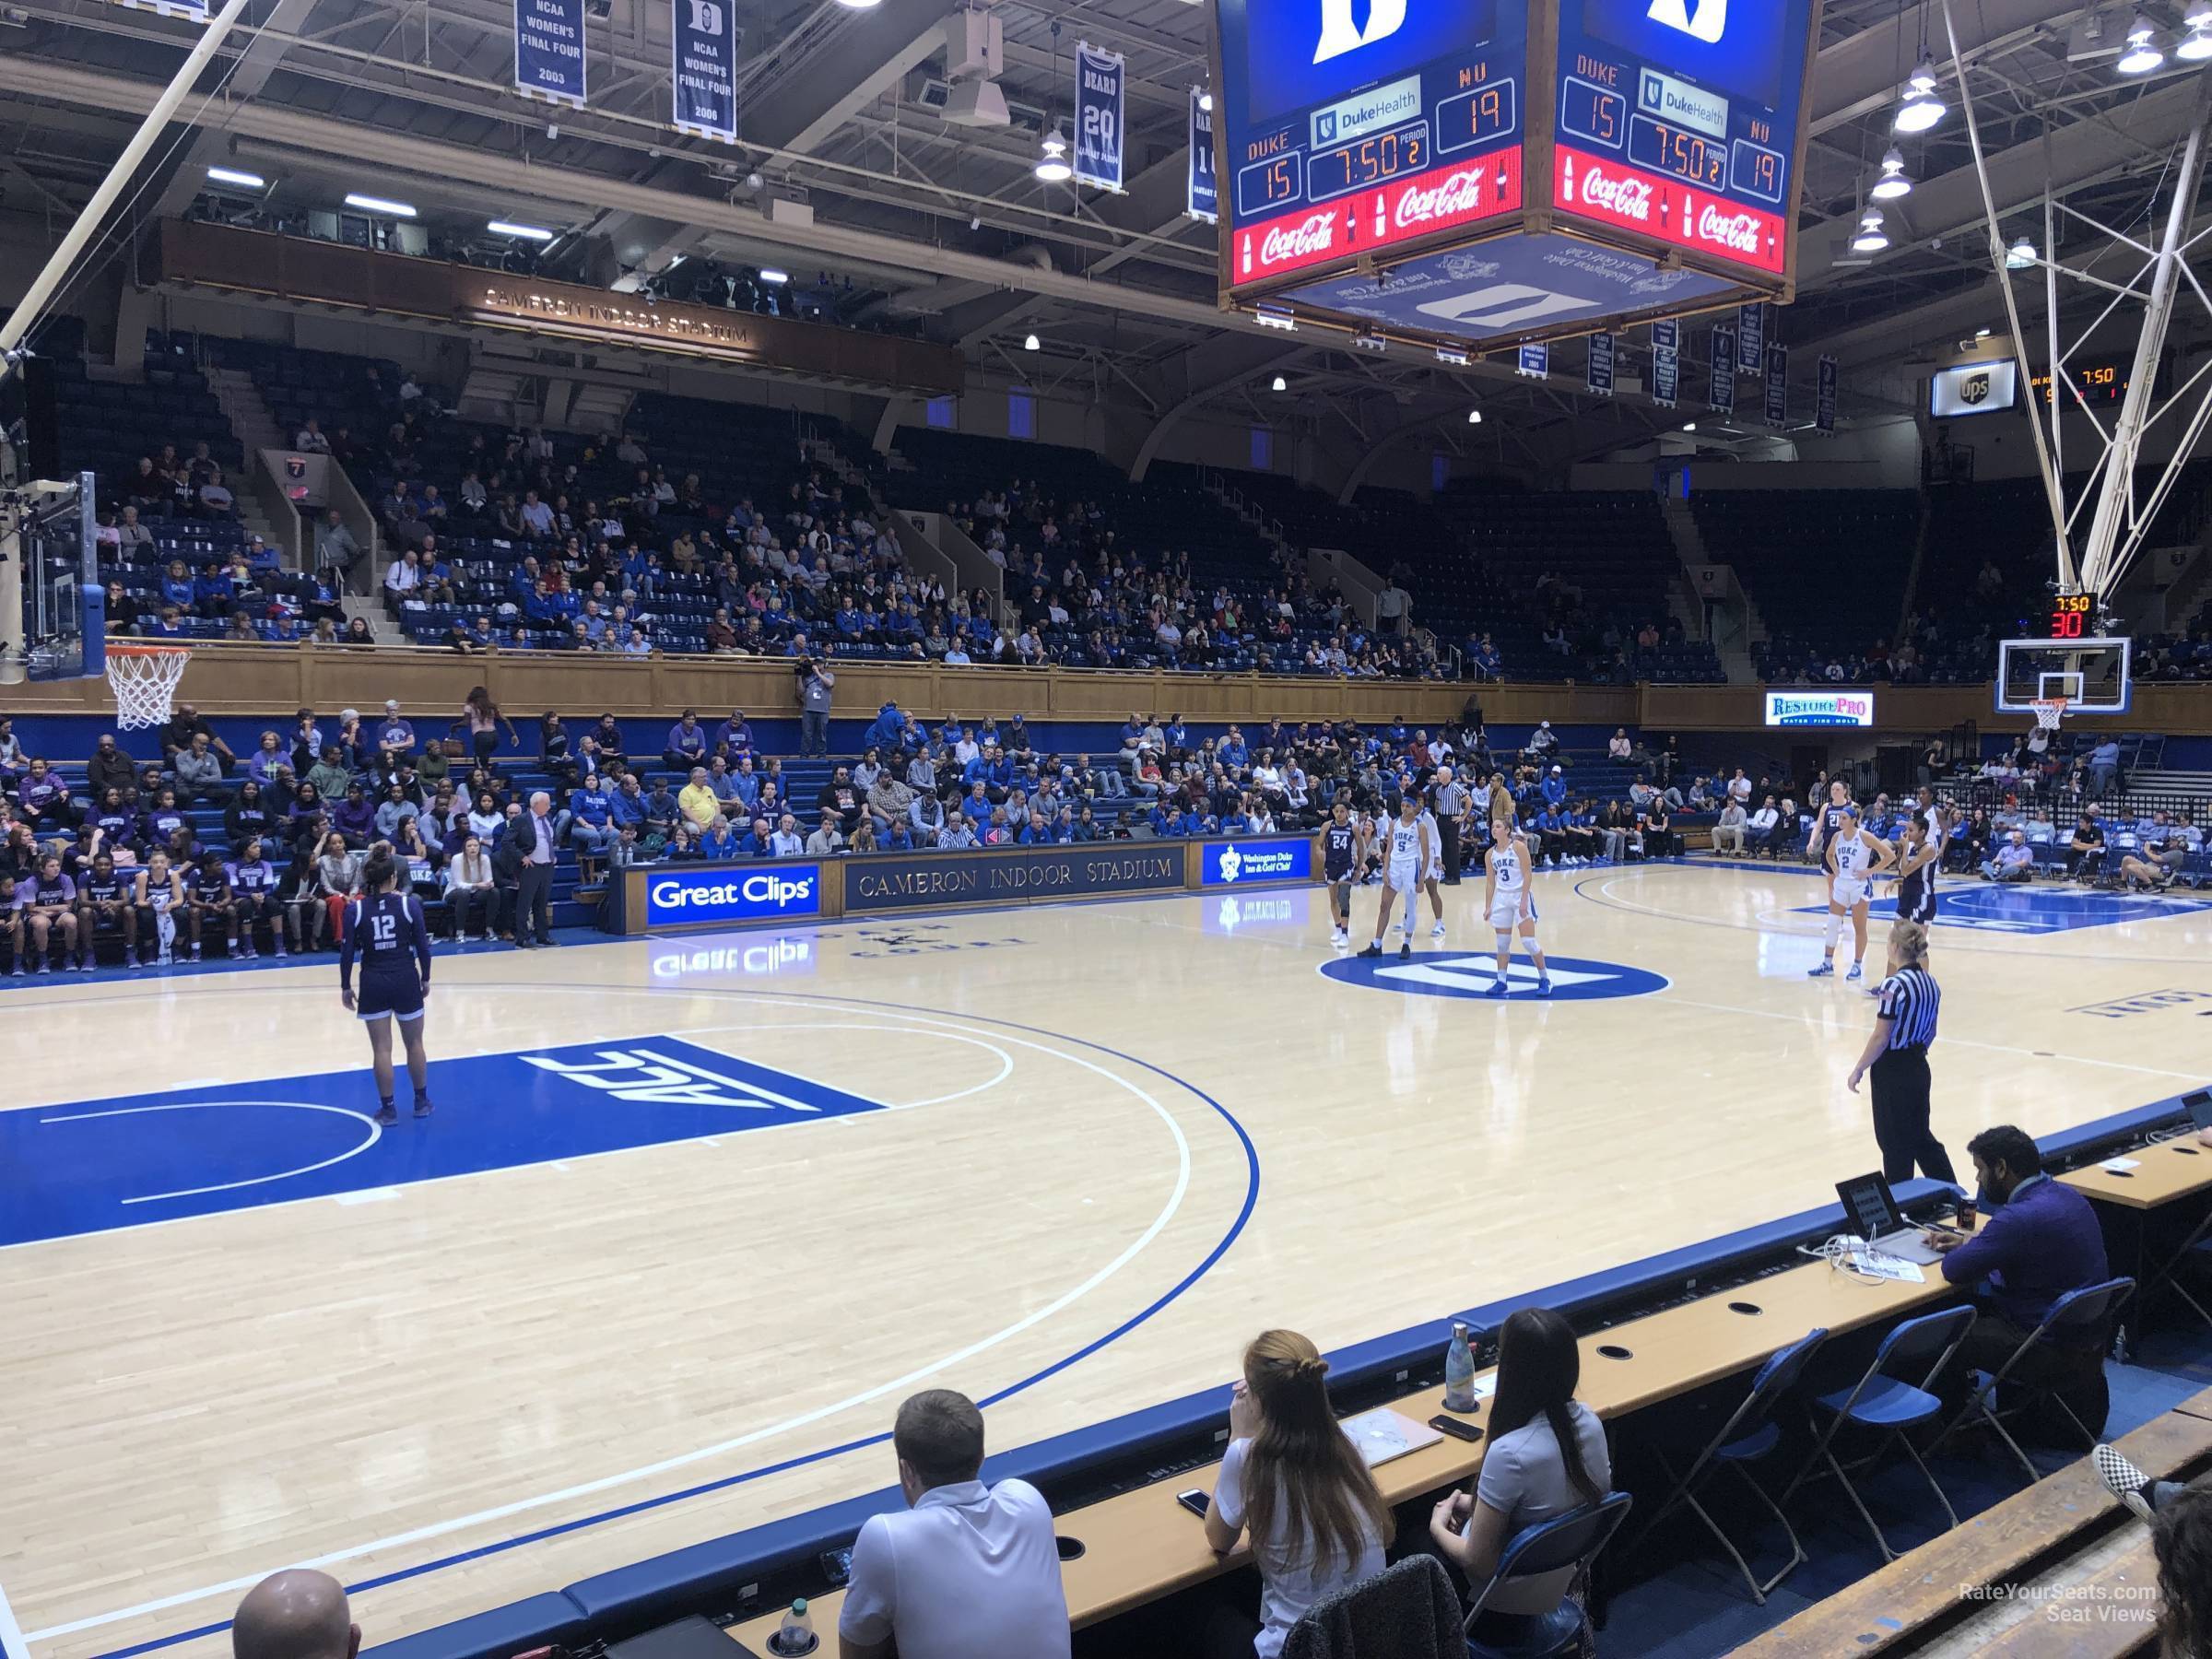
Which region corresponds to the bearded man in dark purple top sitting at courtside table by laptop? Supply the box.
[1928,1124,2108,1433]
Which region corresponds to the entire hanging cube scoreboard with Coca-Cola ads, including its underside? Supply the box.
[1215,0,1820,343]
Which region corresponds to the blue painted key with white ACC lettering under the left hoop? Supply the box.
[0,1038,883,1245]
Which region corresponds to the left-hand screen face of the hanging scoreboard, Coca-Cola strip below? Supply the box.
[1215,0,1528,288]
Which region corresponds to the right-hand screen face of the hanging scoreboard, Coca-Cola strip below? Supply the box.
[1553,0,1818,276]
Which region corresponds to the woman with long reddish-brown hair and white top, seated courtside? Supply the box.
[1206,1332,1392,1659]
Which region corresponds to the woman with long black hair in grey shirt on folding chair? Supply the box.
[1429,1307,1613,1648]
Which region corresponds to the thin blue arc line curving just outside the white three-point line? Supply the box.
[69,986,1259,1659]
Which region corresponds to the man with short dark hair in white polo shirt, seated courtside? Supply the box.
[836,1389,1068,1659]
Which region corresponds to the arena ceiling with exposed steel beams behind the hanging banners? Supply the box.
[0,0,2207,460]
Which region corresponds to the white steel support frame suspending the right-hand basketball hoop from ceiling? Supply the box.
[1942,0,2212,595]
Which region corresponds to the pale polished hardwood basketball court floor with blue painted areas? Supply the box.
[0,867,2212,1659]
